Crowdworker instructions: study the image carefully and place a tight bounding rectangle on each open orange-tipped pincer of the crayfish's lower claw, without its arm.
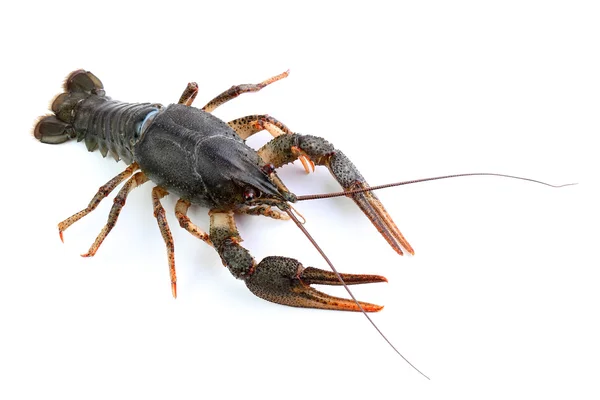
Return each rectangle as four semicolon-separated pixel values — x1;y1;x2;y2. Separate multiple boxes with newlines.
246;257;387;312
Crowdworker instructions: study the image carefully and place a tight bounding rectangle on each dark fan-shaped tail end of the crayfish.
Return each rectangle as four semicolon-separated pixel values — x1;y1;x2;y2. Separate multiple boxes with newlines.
33;69;104;144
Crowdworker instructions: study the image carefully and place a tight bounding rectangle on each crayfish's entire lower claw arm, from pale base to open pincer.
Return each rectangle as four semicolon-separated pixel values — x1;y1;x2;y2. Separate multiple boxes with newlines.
210;210;387;312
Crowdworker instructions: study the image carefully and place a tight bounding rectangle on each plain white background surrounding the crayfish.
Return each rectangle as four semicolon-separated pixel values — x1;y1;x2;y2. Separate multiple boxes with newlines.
0;0;600;399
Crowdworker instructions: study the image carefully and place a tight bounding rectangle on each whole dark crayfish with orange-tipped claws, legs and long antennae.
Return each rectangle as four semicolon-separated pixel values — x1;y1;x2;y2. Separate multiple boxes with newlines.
34;70;572;378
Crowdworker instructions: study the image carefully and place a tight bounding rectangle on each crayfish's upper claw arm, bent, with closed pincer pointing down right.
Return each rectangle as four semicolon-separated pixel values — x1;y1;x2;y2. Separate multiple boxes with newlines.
258;134;414;255
